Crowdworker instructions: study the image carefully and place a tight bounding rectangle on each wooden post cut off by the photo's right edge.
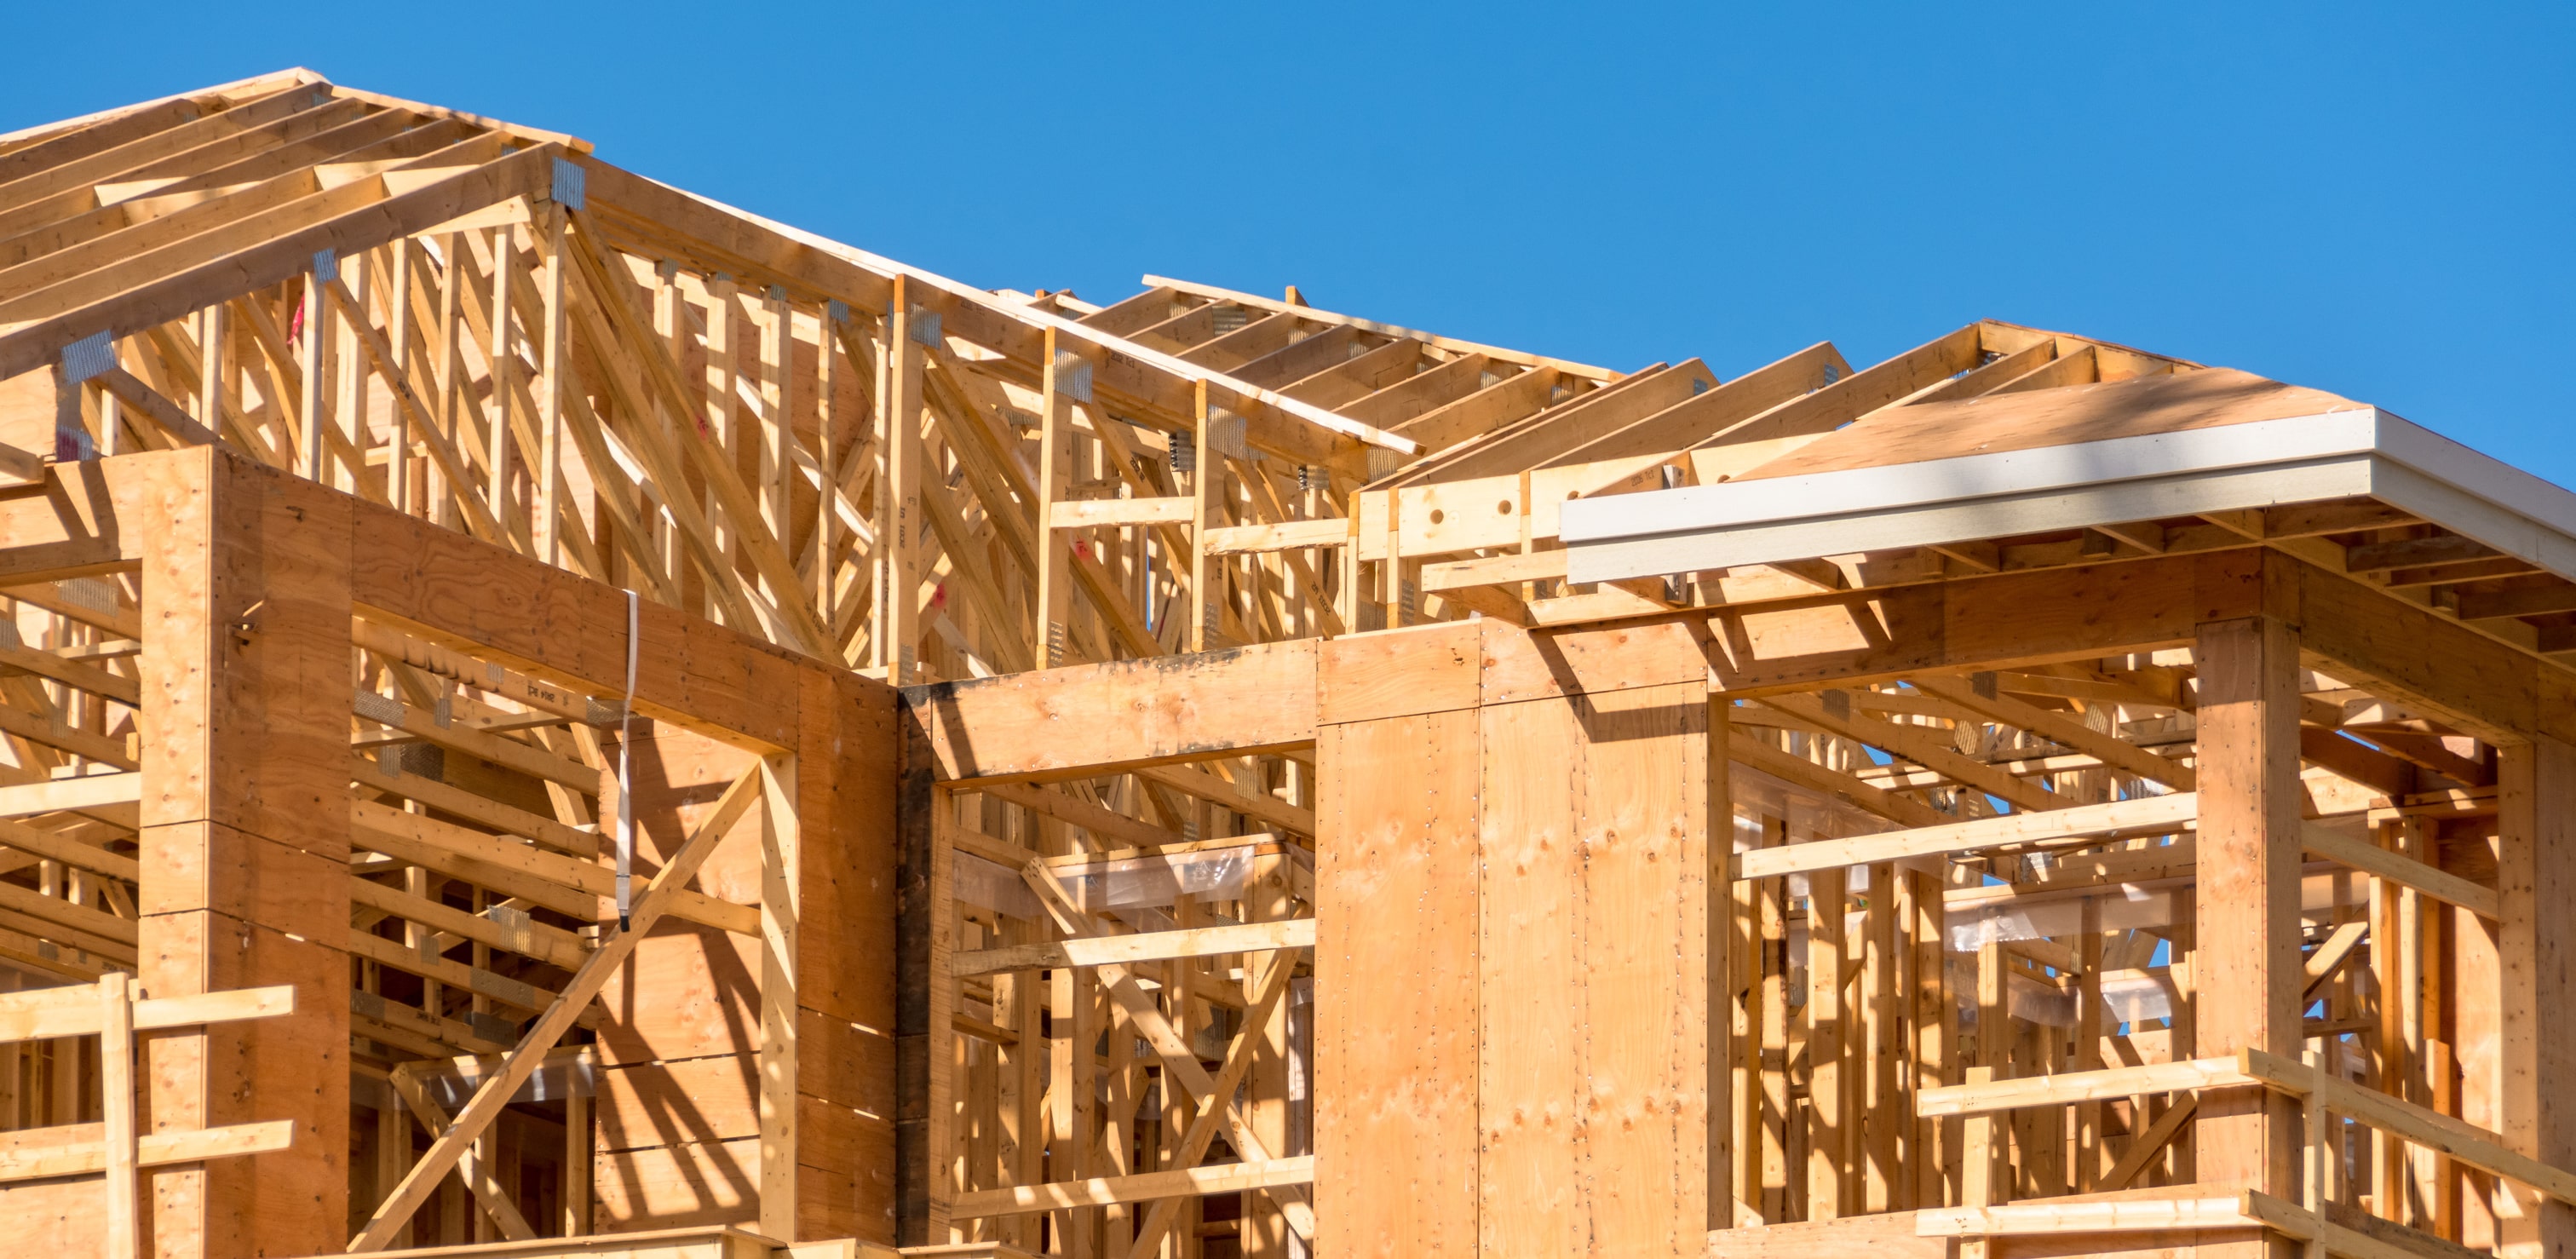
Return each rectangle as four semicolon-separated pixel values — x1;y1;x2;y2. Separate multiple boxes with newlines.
2496;736;2576;1259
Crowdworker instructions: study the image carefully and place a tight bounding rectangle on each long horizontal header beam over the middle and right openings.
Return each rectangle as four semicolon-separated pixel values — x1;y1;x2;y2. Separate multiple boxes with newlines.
904;551;2576;783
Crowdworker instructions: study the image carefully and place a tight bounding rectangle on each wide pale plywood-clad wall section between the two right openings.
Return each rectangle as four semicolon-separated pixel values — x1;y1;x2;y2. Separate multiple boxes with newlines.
1316;623;1723;1254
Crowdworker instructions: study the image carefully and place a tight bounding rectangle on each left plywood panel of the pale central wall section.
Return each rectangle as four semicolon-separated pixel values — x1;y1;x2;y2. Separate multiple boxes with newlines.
1314;710;1481;1256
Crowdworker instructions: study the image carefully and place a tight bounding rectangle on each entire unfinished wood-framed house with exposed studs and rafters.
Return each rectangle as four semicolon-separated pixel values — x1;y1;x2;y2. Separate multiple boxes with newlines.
0;72;2576;1259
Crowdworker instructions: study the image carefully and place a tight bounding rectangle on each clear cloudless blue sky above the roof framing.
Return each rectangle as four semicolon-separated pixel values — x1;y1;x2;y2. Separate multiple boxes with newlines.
0;3;2576;484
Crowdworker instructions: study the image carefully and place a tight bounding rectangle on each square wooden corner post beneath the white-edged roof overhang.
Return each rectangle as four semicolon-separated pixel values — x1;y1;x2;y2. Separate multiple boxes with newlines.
2176;618;2303;1256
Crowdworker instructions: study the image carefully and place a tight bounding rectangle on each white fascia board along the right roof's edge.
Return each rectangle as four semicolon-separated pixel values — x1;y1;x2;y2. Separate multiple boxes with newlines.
1561;407;2576;592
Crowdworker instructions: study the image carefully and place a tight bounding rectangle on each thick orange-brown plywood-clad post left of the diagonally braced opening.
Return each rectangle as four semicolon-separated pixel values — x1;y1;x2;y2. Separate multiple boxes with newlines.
137;448;353;1259
